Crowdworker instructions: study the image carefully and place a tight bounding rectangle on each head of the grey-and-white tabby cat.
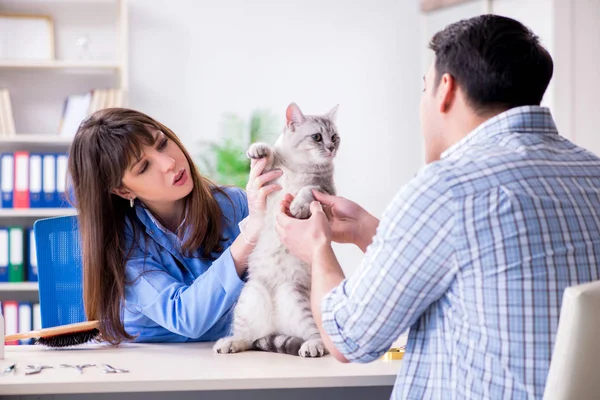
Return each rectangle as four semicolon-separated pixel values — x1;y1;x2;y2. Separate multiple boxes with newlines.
282;103;340;164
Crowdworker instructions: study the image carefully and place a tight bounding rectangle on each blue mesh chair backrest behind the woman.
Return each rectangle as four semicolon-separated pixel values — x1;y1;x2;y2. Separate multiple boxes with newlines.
33;216;86;328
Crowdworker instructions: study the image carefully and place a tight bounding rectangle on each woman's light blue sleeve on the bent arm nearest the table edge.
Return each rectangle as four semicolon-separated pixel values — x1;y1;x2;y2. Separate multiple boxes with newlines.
126;249;244;338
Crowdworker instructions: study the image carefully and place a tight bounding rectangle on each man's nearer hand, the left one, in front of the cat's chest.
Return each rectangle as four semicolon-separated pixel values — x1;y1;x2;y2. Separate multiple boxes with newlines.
275;193;331;264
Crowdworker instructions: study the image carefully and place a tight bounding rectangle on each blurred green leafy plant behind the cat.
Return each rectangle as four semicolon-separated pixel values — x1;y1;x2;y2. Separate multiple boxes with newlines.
197;110;276;188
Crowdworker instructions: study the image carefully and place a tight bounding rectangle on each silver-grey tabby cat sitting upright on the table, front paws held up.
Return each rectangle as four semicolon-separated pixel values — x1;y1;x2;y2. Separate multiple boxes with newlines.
213;103;340;357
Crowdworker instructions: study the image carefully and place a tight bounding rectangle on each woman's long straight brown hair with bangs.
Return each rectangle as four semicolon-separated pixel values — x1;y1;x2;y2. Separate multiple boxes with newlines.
69;108;230;344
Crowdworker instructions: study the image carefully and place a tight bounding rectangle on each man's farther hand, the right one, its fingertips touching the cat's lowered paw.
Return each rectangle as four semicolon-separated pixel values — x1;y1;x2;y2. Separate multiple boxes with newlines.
313;190;379;252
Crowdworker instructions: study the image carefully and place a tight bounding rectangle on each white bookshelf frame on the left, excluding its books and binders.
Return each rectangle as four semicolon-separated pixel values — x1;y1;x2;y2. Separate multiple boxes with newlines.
0;0;128;302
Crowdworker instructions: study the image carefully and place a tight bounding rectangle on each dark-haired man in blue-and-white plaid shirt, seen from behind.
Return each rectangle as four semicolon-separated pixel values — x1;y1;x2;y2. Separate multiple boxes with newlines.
277;15;600;399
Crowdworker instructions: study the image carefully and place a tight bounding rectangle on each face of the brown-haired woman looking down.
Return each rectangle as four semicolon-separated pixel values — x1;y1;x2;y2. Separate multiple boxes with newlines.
119;128;194;206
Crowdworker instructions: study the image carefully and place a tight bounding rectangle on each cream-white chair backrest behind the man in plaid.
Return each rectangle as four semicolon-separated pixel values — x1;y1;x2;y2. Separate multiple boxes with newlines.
544;281;600;400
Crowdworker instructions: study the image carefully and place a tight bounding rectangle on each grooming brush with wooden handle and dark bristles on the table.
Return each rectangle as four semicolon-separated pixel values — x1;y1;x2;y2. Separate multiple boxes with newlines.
4;321;100;347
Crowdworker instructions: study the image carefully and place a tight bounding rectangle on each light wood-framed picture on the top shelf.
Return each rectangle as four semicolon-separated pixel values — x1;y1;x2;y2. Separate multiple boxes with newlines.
0;14;54;60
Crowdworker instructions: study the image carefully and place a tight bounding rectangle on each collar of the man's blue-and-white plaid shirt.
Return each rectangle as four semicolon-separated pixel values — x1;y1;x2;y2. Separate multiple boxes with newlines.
441;106;558;158
